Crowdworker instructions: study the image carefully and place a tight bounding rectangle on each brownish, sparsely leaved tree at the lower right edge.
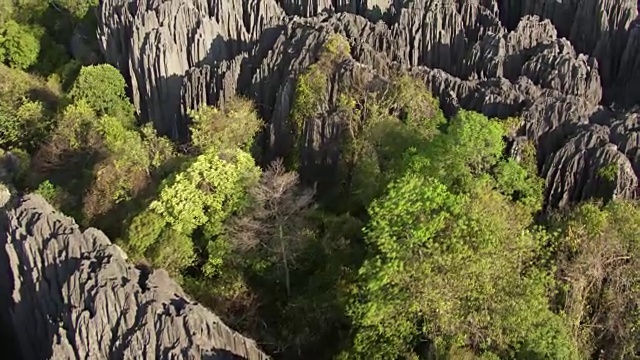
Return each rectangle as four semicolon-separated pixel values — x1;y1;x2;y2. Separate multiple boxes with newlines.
557;204;640;359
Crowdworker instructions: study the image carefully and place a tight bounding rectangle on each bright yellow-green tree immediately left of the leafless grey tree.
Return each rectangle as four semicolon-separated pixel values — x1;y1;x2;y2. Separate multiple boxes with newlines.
124;149;260;275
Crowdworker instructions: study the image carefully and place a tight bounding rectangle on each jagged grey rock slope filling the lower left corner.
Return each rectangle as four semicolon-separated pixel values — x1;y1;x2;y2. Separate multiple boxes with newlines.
0;195;268;360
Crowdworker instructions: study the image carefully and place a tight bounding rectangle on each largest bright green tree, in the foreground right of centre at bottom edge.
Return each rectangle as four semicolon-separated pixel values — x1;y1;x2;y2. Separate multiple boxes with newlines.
342;174;573;359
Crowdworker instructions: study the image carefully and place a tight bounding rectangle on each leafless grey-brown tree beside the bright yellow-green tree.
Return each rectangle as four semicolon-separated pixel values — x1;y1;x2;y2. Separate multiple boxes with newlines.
230;159;315;296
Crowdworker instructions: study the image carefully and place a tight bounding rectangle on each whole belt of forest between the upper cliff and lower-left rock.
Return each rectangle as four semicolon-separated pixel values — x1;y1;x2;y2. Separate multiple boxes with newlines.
0;10;640;360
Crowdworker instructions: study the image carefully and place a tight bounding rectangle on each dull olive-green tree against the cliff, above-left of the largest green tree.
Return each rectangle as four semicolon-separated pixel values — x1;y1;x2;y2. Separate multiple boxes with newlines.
338;75;445;211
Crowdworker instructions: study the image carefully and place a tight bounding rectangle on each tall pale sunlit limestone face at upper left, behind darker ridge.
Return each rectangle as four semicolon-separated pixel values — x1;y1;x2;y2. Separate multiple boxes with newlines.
98;0;284;139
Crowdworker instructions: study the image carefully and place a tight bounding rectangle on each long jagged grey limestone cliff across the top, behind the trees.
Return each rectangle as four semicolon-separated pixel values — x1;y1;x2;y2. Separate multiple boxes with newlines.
99;0;640;206
